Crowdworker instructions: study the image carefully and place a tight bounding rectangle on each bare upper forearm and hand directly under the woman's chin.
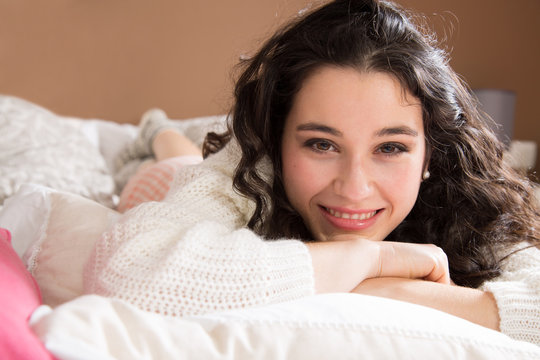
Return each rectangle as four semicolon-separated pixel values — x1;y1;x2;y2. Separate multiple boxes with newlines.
307;234;450;293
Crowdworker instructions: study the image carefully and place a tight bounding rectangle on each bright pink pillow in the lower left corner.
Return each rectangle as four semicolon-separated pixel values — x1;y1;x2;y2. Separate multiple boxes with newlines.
0;228;53;359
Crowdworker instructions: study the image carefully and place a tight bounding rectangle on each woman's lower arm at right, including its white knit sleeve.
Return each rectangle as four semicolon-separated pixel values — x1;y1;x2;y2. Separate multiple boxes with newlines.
353;244;540;345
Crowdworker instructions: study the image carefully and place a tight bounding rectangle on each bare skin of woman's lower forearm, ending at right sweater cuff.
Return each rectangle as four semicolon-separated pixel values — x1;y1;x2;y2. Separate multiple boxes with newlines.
353;277;499;330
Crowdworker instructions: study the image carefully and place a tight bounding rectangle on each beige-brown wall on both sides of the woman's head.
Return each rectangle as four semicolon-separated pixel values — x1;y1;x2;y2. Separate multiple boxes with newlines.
0;0;540;177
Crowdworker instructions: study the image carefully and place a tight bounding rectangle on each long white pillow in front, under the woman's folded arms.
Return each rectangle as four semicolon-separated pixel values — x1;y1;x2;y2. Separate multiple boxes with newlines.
30;294;540;360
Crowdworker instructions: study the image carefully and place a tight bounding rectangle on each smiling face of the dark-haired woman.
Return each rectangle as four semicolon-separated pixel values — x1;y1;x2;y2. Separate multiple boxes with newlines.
282;66;426;241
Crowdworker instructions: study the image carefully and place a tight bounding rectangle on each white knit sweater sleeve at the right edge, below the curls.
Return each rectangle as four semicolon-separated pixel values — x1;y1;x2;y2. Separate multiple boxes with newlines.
481;247;540;345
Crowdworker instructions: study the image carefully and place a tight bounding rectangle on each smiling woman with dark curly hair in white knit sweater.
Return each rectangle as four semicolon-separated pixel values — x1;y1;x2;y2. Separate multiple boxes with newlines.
86;0;540;344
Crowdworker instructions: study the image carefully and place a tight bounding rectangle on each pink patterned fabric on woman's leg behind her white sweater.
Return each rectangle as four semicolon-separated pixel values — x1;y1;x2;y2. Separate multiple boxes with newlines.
117;156;202;212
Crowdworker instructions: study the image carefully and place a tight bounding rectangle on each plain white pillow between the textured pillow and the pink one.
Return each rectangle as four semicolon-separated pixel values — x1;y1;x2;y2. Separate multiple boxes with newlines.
0;184;119;306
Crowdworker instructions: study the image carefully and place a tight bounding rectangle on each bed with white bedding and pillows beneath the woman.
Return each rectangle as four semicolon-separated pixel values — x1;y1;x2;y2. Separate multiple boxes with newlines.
0;95;540;360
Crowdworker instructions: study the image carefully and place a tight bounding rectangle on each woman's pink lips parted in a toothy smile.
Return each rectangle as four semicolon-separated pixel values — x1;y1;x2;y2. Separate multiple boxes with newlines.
319;206;382;231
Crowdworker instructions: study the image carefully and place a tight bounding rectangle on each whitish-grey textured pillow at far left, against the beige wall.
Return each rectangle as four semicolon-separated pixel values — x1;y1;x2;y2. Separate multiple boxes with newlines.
0;96;114;206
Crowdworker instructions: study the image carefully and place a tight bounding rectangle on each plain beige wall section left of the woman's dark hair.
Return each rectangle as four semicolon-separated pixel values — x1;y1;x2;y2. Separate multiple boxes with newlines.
0;0;306;122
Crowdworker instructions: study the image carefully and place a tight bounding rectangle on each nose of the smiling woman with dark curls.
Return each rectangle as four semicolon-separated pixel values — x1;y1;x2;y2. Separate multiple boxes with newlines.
334;161;373;200
